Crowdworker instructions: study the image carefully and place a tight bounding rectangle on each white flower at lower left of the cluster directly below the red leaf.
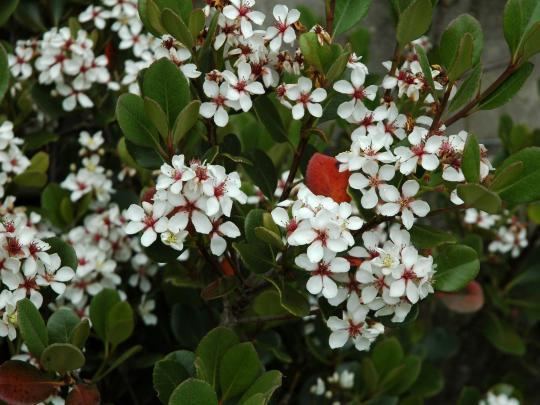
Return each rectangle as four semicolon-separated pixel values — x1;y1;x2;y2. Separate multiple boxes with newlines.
294;249;350;299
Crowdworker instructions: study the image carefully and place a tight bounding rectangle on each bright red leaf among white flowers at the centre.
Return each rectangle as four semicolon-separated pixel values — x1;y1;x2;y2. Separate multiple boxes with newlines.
306;153;351;203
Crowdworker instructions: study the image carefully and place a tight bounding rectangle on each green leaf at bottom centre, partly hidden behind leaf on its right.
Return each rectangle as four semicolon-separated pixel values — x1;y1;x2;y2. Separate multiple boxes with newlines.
195;327;239;388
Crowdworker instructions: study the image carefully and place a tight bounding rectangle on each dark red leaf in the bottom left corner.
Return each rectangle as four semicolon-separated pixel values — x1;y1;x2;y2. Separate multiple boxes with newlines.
0;360;60;405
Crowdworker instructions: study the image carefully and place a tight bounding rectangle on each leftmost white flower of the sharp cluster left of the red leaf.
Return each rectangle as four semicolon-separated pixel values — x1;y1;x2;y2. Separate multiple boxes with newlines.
125;201;168;247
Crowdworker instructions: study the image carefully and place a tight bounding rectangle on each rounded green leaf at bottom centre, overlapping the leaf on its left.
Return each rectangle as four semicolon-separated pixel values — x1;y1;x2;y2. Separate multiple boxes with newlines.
219;342;262;400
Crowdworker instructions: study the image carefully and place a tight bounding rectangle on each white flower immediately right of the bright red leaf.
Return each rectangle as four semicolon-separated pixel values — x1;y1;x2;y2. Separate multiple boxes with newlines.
349;161;396;209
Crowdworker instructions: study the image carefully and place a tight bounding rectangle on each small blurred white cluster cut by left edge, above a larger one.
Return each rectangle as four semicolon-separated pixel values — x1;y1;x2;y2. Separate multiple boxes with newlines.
0;121;30;198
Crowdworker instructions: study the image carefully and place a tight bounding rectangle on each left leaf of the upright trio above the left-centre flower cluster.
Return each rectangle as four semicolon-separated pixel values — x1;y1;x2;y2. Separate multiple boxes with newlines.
116;93;159;149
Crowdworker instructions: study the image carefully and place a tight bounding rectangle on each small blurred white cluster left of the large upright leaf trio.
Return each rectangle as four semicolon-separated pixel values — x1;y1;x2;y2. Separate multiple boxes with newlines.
61;131;114;203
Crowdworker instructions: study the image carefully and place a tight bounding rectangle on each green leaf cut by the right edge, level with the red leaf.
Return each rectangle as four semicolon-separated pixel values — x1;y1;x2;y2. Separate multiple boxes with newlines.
497;146;540;204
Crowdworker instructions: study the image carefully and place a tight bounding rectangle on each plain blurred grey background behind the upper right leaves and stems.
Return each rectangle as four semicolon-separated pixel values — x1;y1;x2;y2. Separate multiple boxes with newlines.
257;0;540;143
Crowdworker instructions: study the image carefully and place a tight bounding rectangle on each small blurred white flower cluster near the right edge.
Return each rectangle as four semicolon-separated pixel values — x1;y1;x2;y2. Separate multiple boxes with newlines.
464;208;529;257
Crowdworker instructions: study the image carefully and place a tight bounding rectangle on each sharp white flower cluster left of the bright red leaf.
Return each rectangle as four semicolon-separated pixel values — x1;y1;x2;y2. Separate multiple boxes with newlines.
125;155;247;256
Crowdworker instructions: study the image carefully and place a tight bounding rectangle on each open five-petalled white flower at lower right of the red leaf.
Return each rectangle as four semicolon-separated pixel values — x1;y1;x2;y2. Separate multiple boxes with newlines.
380;180;429;229
